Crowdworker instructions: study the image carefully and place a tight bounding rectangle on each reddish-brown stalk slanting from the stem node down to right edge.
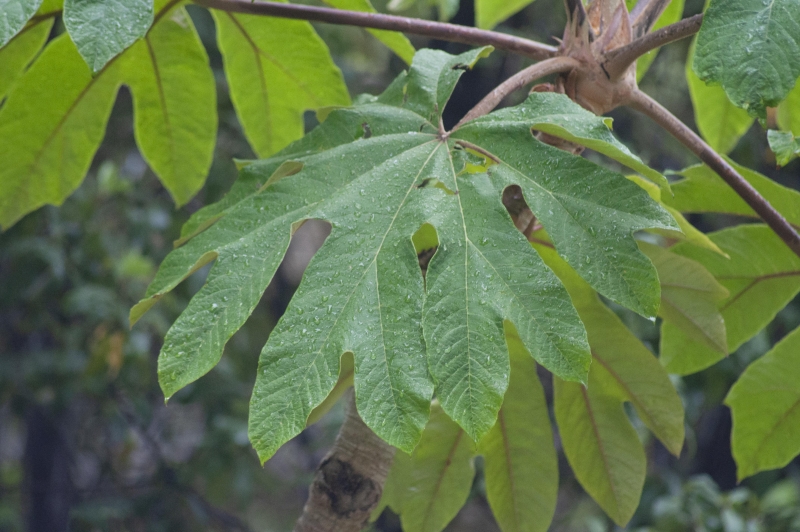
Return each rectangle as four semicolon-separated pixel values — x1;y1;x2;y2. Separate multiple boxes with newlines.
627;89;800;257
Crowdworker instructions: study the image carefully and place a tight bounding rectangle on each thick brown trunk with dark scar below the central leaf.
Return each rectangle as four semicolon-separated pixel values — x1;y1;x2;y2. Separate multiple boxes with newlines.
294;389;395;532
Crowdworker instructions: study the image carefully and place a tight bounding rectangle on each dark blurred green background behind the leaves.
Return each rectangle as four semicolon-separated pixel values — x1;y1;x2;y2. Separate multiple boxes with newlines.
0;0;800;532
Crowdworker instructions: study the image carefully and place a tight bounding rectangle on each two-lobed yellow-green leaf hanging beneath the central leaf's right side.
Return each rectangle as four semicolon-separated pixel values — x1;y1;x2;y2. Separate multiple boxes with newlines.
536;244;684;525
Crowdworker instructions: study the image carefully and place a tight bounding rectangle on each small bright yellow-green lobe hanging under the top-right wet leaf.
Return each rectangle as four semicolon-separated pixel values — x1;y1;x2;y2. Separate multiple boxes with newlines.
686;38;755;153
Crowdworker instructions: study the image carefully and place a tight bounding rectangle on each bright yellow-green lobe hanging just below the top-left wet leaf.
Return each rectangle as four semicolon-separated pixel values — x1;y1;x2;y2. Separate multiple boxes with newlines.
121;5;217;205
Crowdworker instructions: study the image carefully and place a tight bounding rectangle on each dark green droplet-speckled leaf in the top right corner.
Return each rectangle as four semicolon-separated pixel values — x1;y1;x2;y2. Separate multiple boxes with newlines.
694;0;800;117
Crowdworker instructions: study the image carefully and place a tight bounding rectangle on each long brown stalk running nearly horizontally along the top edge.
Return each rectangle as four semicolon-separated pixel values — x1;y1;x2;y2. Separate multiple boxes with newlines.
194;0;557;59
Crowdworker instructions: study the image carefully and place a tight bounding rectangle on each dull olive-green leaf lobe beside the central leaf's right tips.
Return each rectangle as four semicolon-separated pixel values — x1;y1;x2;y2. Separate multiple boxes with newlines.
639;242;728;355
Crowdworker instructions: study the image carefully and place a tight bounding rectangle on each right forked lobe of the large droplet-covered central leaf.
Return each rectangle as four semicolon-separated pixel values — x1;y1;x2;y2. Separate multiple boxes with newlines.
453;109;678;317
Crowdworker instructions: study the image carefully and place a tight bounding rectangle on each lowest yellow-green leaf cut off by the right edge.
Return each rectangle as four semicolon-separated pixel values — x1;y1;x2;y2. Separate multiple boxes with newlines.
725;329;800;480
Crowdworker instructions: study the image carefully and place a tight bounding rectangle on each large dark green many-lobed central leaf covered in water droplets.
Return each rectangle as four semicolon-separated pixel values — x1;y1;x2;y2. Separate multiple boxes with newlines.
131;49;677;459
